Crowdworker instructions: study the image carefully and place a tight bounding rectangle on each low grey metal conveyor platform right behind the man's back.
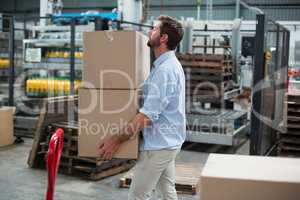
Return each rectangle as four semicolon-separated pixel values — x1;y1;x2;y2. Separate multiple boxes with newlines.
186;109;249;146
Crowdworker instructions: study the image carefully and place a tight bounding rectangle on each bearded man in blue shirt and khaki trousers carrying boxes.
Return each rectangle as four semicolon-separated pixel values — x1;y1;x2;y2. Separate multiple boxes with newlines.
100;16;186;200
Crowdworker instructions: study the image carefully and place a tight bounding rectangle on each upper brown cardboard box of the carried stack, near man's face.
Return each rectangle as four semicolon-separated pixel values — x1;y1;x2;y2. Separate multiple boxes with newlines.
82;31;150;89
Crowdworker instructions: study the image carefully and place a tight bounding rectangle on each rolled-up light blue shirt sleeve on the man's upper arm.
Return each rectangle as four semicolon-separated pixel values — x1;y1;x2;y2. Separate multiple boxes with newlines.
139;70;175;122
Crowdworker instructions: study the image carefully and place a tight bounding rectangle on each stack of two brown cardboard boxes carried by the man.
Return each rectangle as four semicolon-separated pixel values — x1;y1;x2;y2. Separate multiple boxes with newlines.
78;31;150;159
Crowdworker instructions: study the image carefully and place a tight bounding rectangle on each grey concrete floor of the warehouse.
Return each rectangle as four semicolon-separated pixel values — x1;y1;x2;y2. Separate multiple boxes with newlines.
0;139;248;200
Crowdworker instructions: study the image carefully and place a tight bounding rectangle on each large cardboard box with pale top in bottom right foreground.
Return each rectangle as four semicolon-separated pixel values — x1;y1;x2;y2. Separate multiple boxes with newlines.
200;154;300;200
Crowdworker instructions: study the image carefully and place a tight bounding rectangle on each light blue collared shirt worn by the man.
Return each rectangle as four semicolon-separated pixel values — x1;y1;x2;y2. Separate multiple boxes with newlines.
139;51;186;150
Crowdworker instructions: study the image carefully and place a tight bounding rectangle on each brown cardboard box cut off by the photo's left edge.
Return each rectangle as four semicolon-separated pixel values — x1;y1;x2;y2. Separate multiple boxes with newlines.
0;107;15;147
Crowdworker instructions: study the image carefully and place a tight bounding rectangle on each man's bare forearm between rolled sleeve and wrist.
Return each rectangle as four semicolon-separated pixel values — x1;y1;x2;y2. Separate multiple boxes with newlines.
118;113;151;143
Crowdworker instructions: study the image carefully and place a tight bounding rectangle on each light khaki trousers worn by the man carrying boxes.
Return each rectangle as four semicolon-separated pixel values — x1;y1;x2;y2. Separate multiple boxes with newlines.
128;149;180;200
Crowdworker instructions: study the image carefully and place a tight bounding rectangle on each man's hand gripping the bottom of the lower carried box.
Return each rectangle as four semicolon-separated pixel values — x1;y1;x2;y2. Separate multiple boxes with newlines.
99;135;122;160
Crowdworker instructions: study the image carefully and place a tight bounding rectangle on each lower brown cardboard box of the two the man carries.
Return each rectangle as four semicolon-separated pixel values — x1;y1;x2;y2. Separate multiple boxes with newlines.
78;89;138;159
